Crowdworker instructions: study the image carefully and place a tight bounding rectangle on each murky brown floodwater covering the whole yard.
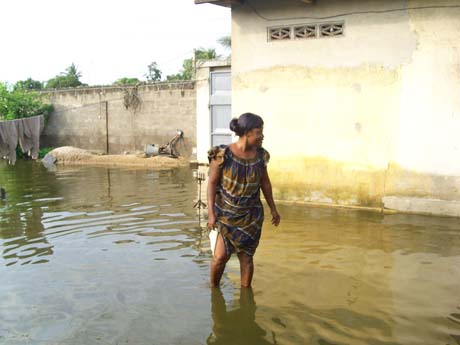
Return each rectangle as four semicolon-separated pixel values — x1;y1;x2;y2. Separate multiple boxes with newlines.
0;161;460;345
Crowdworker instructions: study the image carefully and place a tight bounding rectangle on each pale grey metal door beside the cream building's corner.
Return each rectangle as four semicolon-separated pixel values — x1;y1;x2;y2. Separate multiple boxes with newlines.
209;71;232;146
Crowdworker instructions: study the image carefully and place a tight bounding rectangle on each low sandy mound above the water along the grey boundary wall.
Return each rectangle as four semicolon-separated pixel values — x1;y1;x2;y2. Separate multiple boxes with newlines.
48;146;189;168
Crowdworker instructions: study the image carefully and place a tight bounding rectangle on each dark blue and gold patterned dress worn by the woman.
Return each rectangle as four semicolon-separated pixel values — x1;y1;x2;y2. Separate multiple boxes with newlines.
208;145;270;256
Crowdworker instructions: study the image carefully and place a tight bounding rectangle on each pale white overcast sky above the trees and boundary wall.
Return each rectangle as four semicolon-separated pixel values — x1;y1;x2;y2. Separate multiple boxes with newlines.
0;0;231;85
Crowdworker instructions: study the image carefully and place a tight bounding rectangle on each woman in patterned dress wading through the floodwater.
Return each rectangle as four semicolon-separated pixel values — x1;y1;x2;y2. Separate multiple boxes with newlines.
208;113;280;287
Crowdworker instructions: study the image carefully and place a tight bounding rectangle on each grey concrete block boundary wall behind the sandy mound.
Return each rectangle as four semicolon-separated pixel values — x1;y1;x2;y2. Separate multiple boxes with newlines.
41;82;196;158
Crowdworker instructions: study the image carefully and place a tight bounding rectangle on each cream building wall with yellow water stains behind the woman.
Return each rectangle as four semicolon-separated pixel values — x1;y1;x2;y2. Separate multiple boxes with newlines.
195;0;460;216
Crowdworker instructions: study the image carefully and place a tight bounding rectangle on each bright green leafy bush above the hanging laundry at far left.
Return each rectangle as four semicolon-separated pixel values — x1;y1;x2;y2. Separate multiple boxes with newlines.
0;83;53;120
